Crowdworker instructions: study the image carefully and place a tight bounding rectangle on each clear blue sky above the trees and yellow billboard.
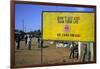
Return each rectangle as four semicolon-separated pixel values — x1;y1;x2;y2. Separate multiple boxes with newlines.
15;4;94;32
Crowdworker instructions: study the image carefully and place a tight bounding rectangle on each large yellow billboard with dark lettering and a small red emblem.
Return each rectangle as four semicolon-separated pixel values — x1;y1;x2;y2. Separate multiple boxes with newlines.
43;12;94;41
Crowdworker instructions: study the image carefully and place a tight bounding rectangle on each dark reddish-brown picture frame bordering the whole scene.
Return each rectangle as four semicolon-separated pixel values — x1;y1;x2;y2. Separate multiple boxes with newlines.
10;0;96;69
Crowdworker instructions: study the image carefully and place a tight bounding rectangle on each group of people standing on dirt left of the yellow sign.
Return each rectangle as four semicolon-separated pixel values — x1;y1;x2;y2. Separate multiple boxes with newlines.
16;35;41;50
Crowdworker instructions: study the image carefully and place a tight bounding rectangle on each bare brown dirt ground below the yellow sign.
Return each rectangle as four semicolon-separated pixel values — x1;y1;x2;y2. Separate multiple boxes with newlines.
15;38;79;66
